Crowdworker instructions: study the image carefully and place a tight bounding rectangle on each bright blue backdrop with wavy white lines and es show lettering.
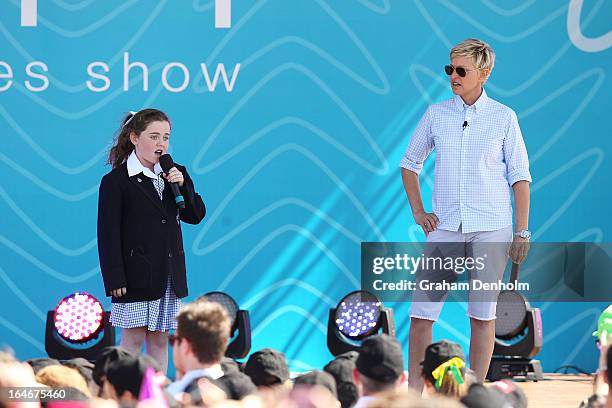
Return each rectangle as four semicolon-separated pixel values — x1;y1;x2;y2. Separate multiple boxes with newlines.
0;0;612;371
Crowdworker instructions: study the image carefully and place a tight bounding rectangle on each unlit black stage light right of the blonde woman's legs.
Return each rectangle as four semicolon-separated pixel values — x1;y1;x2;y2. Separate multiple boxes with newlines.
487;263;543;381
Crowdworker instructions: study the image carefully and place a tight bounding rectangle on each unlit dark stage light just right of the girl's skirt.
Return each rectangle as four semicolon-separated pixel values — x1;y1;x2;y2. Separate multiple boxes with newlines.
200;291;251;359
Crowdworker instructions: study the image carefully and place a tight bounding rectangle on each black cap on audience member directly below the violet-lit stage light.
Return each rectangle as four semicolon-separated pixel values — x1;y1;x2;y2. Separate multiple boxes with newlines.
355;334;404;383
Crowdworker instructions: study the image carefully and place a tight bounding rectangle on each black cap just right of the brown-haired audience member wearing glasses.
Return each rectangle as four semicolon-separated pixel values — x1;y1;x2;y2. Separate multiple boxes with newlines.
244;348;289;386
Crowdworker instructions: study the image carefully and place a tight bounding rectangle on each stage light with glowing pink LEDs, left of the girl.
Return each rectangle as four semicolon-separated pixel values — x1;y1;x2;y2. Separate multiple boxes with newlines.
45;292;115;361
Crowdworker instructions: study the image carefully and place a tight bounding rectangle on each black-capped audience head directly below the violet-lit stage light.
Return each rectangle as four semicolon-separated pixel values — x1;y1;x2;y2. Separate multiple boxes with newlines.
353;334;406;395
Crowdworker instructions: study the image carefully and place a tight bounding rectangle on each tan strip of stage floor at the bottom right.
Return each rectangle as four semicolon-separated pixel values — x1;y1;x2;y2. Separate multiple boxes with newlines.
515;374;593;408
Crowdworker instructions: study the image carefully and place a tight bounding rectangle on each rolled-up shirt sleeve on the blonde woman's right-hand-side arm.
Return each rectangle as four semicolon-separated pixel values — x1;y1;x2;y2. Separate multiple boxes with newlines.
504;111;531;186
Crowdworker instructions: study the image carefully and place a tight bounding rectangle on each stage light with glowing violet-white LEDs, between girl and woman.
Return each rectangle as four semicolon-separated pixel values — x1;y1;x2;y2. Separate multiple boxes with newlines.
327;290;395;356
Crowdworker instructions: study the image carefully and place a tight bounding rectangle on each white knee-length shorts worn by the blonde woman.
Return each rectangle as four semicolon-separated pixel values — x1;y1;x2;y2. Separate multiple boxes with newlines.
410;225;514;321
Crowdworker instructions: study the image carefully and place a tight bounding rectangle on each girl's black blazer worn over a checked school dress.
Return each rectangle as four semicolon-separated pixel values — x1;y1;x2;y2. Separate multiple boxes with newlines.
98;163;206;303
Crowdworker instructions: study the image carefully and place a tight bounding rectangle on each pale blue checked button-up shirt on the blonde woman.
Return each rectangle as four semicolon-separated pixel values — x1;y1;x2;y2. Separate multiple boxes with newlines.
400;89;531;233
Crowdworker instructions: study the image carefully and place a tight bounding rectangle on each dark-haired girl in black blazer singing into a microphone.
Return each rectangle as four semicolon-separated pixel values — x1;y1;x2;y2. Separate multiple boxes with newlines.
98;109;206;372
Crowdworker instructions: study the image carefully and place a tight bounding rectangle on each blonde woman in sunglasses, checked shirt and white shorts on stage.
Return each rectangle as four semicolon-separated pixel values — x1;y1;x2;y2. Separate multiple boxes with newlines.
400;38;531;390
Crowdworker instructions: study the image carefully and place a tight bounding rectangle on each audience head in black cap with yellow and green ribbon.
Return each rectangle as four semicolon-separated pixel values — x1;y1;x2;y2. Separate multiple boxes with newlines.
421;340;467;398
